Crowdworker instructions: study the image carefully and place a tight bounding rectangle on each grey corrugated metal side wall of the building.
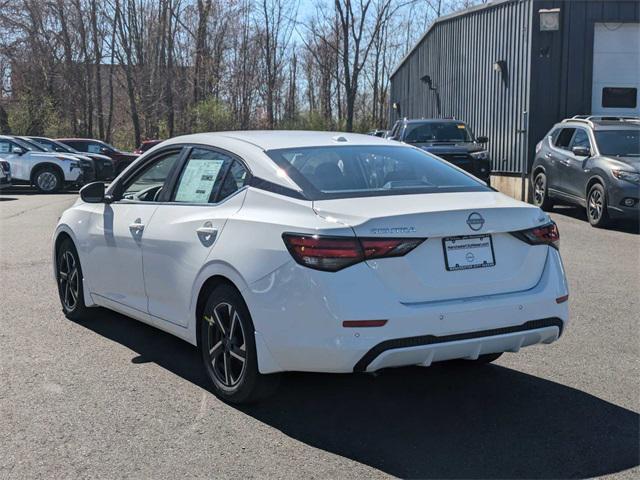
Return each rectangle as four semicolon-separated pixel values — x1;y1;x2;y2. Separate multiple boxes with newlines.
390;0;531;174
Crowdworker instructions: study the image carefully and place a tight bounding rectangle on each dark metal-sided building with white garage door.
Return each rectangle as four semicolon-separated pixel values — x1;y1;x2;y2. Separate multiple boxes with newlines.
390;0;640;198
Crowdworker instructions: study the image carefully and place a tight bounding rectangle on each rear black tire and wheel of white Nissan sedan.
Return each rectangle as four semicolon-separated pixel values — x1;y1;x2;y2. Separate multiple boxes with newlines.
200;285;280;404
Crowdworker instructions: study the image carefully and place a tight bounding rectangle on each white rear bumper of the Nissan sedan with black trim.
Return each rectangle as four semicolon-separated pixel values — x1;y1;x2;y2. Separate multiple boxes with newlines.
243;248;568;373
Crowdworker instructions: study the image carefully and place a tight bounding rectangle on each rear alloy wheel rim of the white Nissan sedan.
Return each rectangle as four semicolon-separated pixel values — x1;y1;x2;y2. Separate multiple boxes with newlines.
204;302;247;390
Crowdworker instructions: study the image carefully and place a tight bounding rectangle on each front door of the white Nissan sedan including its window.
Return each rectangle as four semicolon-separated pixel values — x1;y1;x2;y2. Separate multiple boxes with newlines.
85;149;181;314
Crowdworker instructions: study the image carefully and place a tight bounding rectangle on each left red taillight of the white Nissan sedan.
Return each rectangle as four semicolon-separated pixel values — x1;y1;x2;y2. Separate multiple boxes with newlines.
282;233;425;272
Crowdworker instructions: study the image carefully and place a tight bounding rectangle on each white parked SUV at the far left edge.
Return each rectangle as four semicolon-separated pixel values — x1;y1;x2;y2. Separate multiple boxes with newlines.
0;135;93;193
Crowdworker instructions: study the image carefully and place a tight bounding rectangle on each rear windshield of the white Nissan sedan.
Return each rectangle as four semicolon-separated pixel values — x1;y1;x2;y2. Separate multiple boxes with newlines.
266;145;491;200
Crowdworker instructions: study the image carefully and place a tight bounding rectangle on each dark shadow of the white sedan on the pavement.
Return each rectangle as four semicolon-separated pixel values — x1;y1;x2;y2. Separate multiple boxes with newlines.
81;309;640;478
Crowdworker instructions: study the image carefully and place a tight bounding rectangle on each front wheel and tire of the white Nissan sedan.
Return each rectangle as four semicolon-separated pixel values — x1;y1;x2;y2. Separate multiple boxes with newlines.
56;238;88;320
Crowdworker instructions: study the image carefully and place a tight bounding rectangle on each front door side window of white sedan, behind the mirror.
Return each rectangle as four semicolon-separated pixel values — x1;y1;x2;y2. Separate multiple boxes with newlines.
122;150;181;202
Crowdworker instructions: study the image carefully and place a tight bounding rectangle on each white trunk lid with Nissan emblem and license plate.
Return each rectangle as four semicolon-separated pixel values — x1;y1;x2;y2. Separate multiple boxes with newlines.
314;192;549;303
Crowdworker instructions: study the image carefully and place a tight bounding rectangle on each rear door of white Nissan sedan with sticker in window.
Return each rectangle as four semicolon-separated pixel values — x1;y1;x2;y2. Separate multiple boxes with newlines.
142;148;249;326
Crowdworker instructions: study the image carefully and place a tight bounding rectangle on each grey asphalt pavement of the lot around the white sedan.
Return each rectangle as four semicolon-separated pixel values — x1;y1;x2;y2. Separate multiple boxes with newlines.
0;189;640;479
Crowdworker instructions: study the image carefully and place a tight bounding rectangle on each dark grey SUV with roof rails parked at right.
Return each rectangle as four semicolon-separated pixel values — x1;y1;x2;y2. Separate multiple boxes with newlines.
531;116;640;227
